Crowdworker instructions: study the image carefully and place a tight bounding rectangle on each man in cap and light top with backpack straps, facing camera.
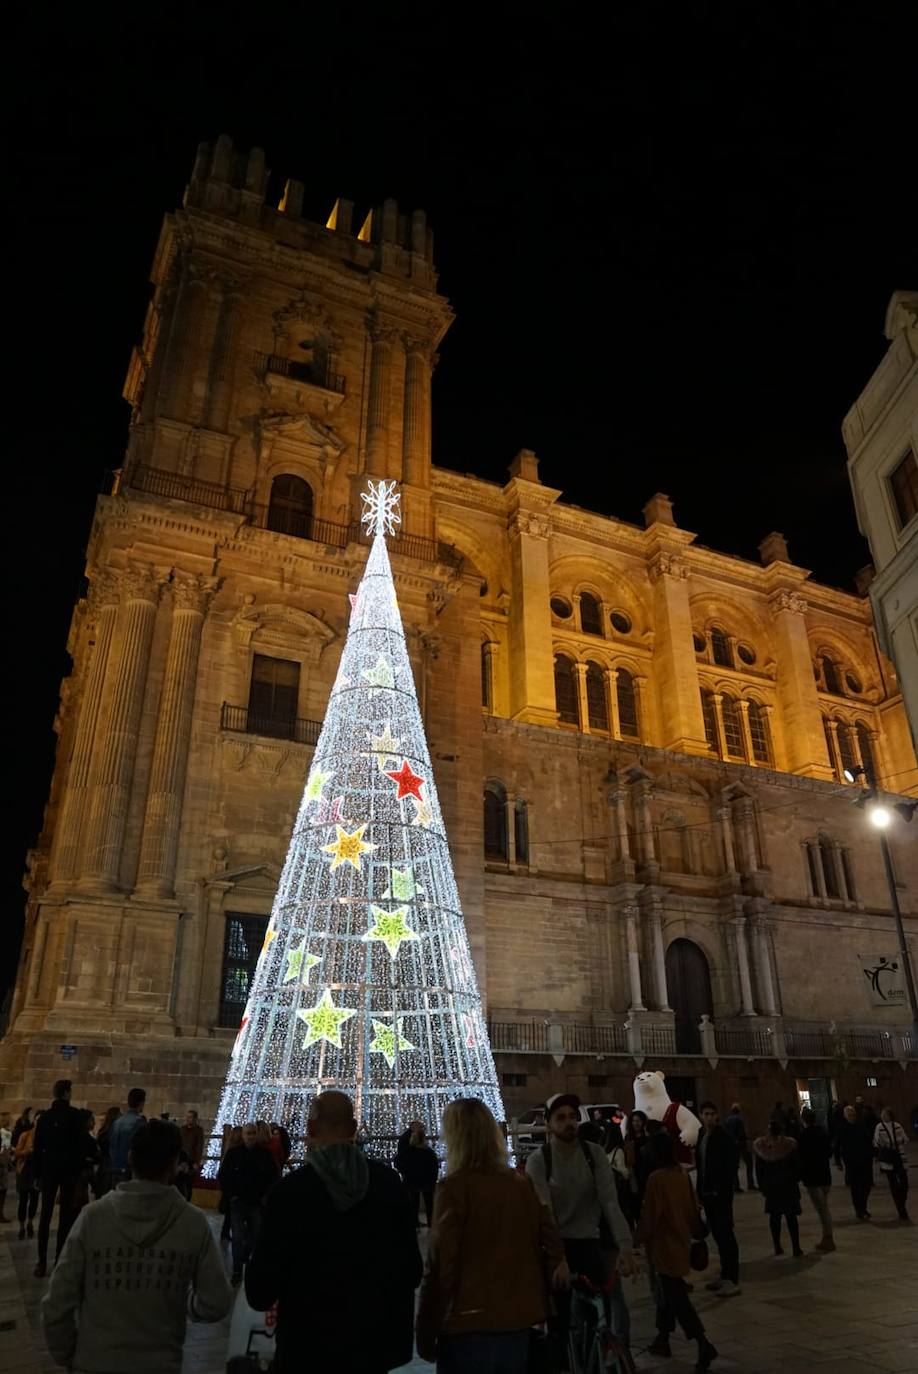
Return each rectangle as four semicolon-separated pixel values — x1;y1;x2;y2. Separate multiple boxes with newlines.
526;1092;635;1351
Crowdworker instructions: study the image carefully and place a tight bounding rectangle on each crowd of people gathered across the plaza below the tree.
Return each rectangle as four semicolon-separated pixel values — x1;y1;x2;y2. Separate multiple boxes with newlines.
0;1080;908;1374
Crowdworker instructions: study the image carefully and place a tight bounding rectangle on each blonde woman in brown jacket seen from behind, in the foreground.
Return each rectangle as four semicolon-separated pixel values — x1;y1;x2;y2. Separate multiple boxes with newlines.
418;1098;569;1374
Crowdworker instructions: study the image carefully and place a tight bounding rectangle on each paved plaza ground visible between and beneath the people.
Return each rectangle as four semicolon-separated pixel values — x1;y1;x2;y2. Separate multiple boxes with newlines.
0;1158;918;1374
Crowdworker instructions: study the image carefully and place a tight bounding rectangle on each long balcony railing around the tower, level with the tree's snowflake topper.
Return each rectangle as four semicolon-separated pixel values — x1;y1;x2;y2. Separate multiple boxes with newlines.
122;467;462;567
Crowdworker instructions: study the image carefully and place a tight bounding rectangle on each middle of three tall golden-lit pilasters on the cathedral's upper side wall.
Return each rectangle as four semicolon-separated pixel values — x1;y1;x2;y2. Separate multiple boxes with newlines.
650;551;709;754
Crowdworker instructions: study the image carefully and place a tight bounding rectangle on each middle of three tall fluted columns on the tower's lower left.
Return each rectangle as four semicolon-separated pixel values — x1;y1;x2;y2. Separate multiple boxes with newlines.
80;570;159;892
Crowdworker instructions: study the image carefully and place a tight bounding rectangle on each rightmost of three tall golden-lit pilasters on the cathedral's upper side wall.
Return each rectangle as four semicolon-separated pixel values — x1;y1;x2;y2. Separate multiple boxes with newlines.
770;588;831;780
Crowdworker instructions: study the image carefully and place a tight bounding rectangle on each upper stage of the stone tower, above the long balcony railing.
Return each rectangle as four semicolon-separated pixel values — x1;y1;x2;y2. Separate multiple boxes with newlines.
125;135;452;539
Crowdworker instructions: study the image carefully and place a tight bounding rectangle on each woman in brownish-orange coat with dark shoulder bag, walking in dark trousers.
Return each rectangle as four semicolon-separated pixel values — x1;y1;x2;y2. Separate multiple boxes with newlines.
635;1131;717;1370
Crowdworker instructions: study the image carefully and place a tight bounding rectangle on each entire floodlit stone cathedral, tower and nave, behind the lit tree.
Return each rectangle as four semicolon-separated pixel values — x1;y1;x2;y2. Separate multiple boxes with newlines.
0;137;918;1124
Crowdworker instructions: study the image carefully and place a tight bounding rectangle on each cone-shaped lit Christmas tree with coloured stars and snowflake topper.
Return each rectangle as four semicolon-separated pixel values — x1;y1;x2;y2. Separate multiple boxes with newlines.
206;482;503;1153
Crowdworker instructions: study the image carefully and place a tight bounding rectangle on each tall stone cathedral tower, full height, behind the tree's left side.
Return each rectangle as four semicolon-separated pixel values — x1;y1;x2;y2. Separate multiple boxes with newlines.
0;136;456;1103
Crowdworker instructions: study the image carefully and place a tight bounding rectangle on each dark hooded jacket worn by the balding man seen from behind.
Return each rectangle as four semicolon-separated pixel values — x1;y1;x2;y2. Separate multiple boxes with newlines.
246;1145;422;1374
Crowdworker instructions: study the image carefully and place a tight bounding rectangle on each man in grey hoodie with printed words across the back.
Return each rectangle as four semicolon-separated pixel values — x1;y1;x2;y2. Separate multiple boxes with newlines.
41;1121;234;1374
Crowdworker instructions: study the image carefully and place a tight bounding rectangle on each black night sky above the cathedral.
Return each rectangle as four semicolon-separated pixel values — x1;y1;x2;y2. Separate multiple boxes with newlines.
0;3;918;996
